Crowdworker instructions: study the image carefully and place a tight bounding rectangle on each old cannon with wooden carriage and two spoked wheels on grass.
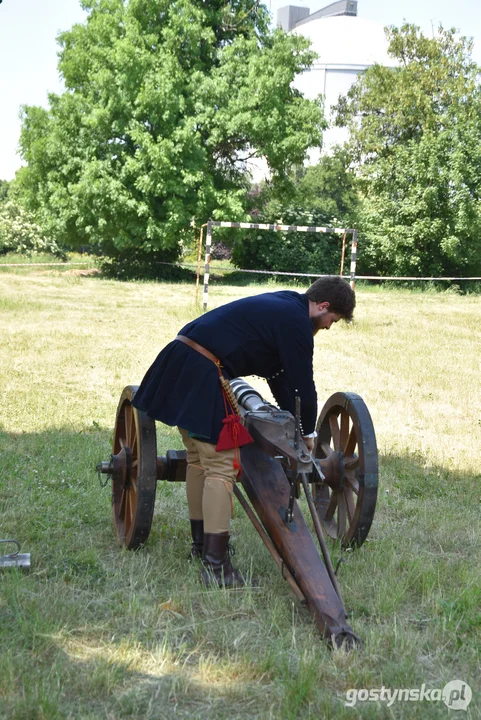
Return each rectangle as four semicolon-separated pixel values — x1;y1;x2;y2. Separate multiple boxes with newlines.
97;378;378;647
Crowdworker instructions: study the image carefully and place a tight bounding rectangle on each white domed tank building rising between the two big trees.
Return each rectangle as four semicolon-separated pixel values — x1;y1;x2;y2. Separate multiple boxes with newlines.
277;0;395;153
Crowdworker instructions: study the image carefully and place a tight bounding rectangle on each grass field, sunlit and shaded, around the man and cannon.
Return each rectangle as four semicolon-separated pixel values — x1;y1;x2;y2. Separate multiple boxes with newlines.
0;268;481;720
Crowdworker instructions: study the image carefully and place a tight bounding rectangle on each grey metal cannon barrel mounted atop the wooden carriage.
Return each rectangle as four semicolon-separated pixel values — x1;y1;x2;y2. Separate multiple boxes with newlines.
230;378;313;477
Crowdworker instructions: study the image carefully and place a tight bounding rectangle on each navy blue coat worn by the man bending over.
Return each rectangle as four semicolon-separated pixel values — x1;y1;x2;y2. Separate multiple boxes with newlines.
134;291;317;444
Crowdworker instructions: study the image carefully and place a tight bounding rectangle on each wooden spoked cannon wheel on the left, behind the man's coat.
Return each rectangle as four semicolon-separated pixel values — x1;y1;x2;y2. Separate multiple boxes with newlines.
109;385;157;550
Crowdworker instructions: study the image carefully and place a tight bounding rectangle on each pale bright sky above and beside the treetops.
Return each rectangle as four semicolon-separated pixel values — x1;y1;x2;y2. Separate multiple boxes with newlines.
0;0;481;180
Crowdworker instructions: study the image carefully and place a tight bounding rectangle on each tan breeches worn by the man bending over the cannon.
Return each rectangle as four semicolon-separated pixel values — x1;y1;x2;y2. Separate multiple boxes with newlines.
179;428;237;533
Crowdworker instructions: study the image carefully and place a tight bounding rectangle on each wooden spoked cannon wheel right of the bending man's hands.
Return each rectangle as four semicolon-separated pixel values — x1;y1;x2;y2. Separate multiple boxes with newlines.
312;392;378;547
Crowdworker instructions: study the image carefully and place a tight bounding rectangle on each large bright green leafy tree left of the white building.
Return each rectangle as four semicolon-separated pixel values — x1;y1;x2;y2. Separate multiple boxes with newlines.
19;0;323;256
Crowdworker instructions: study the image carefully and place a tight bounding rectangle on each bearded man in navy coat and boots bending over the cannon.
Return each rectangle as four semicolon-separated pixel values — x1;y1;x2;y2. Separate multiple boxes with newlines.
134;276;356;587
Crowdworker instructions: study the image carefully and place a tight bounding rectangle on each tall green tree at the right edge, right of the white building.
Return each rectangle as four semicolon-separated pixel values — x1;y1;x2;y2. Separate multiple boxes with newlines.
337;25;481;276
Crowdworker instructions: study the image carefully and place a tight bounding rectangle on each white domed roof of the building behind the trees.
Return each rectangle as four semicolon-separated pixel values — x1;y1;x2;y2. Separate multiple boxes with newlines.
291;15;396;67
